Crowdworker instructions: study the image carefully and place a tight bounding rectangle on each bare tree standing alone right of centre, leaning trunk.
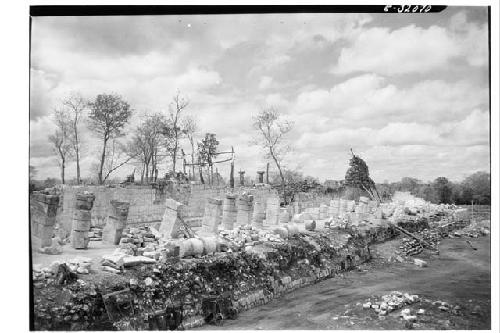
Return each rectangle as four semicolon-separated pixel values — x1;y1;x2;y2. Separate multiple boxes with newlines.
253;107;293;202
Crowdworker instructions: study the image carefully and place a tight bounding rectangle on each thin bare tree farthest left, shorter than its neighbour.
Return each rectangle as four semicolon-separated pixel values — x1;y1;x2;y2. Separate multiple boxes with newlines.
49;109;72;184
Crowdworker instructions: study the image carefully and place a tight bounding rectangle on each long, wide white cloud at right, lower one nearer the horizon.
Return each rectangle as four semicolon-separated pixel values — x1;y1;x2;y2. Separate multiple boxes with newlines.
293;74;488;130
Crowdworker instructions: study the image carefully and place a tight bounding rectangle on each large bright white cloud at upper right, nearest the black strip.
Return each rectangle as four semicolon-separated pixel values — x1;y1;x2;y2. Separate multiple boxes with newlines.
332;13;488;76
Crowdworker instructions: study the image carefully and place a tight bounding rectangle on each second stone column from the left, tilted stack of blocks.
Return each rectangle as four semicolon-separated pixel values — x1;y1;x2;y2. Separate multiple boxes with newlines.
71;192;95;249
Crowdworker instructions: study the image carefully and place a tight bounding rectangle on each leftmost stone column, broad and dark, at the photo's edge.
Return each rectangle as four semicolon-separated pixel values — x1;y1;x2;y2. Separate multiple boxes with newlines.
30;191;59;247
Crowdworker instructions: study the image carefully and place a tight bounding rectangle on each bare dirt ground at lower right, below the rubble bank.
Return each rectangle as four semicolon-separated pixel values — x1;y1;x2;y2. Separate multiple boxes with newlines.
199;236;491;330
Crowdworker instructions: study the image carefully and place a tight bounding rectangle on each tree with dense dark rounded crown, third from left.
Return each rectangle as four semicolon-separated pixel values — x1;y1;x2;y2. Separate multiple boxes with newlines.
89;94;132;184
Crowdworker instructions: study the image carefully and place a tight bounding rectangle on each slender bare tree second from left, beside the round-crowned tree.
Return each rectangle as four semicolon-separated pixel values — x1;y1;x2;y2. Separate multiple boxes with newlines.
62;93;88;184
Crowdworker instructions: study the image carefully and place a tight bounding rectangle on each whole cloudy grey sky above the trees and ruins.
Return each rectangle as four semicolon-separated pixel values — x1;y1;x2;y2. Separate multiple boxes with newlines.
30;7;489;182
